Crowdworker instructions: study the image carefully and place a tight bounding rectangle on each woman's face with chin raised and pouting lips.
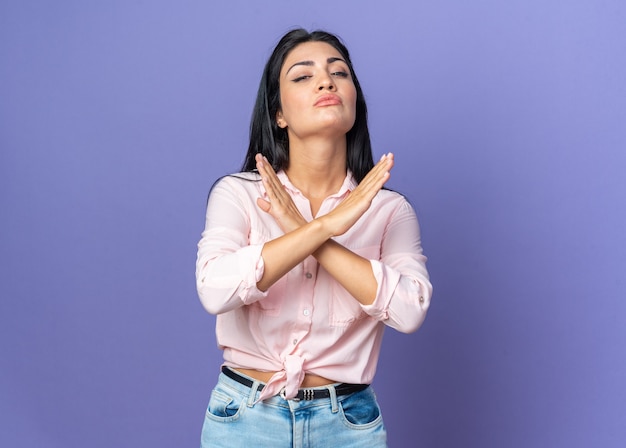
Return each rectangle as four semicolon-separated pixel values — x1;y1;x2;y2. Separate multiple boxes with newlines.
276;42;357;141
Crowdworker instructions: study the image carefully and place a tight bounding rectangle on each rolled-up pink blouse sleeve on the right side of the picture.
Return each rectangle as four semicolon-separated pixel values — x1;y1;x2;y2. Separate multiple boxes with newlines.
363;201;432;333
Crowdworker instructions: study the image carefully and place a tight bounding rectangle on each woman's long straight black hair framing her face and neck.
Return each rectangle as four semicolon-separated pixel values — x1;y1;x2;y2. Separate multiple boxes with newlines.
241;28;374;182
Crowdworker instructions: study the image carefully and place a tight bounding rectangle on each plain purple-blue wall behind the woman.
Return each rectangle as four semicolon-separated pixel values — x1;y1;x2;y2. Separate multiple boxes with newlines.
0;0;626;448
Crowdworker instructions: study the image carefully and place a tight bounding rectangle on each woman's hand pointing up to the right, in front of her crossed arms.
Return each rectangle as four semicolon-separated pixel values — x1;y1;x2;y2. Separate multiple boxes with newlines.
318;153;394;236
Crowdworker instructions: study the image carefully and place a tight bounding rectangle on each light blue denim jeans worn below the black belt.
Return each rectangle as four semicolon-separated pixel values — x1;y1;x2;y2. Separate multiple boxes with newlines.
201;373;387;448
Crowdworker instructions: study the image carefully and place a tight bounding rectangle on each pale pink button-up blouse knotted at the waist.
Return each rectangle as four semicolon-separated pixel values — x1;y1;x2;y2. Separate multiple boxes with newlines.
196;171;432;400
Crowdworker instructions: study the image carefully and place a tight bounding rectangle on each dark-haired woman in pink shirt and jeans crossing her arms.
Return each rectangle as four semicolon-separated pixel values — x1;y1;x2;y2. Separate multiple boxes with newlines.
196;29;432;448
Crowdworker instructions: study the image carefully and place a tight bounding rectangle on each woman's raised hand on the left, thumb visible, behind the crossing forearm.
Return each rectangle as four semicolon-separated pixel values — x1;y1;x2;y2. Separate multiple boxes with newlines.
255;154;307;233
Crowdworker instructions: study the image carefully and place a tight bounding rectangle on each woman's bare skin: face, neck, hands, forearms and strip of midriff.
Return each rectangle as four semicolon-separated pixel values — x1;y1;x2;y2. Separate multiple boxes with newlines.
234;42;394;387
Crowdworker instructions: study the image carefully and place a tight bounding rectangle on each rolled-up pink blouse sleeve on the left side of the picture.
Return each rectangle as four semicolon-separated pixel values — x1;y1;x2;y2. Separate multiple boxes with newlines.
196;178;266;314
